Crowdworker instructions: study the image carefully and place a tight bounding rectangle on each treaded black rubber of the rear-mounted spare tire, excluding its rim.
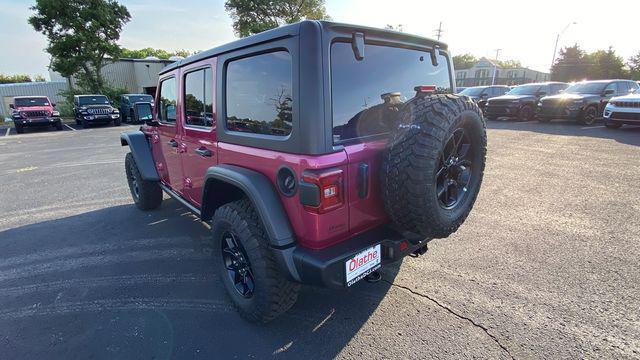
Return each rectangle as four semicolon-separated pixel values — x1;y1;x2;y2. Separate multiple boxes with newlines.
381;95;487;238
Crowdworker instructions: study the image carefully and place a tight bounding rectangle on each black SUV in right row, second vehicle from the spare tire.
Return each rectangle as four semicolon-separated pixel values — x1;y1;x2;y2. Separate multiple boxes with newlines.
485;82;569;121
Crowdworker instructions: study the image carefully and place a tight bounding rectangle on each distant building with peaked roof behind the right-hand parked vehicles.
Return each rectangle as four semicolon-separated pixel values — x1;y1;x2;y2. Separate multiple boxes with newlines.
455;57;549;87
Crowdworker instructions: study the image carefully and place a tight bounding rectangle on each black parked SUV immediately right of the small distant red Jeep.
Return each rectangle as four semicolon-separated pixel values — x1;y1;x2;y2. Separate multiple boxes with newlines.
73;95;121;128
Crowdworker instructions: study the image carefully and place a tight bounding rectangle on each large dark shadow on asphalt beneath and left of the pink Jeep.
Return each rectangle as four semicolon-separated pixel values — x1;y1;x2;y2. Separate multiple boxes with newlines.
0;200;399;359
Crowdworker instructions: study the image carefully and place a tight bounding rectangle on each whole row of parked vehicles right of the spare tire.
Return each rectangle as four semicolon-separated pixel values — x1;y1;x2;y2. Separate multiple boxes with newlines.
459;79;640;127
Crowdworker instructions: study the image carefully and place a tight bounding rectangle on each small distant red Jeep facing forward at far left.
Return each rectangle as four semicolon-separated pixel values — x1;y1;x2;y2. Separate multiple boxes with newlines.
9;96;62;134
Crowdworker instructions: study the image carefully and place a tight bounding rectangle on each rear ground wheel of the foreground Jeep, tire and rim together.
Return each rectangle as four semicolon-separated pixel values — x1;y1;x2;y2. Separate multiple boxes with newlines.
211;198;300;323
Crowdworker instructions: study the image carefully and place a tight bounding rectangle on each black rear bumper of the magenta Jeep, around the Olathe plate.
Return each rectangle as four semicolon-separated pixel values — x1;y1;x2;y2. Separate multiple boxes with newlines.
273;226;427;288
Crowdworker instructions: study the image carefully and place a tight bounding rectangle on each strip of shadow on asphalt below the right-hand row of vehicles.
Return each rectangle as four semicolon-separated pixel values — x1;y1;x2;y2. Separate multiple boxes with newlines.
487;120;640;146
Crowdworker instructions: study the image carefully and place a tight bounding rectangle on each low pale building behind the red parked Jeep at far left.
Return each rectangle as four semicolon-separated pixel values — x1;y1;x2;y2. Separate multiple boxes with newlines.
0;81;67;117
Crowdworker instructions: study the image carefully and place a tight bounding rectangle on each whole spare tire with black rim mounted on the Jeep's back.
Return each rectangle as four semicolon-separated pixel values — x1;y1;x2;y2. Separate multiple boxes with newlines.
381;95;487;238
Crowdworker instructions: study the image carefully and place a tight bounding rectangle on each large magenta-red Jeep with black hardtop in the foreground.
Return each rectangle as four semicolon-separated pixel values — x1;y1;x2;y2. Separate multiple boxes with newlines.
121;21;486;322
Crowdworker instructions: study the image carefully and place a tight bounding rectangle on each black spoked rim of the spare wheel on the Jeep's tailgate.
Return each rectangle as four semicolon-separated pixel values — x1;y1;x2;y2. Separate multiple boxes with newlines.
435;127;475;209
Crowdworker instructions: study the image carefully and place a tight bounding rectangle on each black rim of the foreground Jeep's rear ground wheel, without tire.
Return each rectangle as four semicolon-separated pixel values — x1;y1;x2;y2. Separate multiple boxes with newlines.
220;231;255;299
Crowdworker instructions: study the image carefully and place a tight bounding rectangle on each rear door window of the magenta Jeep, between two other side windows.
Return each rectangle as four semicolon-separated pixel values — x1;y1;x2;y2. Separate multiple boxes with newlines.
184;68;213;128
